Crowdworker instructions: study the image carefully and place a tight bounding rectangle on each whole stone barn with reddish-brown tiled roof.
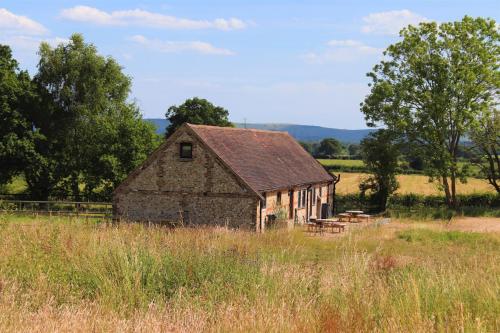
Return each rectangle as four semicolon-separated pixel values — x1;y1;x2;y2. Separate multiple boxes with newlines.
113;124;334;231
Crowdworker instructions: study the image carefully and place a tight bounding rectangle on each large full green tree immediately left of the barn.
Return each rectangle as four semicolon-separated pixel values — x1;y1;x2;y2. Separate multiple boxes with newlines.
29;34;156;200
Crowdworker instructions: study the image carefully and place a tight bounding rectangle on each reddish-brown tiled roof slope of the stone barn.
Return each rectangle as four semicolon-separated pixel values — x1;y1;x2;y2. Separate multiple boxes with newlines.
188;124;333;192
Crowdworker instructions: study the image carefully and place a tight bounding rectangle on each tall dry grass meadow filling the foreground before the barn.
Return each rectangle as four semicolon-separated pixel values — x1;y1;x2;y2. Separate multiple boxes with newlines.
0;215;500;332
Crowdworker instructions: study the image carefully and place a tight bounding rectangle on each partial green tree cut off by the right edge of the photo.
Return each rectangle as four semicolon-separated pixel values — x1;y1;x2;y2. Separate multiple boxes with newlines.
469;109;500;193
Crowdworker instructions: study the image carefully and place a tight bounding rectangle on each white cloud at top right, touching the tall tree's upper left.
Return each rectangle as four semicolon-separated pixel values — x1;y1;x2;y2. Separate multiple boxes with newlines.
361;9;429;35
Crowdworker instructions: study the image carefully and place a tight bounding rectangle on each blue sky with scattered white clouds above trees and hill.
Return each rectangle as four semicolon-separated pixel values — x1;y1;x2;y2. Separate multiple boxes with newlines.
0;0;500;129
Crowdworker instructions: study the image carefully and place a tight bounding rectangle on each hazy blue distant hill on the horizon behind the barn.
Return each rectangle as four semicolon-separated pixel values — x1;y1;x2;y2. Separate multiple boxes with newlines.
146;119;374;143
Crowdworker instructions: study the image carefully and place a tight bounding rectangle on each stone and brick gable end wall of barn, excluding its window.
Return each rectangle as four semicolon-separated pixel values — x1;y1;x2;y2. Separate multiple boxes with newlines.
113;130;258;229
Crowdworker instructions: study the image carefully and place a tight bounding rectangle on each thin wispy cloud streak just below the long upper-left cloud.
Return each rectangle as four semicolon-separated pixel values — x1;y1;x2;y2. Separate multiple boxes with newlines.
130;35;234;56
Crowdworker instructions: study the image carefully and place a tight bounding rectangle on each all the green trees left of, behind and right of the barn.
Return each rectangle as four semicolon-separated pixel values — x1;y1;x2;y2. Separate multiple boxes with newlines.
0;17;500;208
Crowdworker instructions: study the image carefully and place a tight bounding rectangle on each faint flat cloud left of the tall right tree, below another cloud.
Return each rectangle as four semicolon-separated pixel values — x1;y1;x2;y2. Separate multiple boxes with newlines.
302;39;382;64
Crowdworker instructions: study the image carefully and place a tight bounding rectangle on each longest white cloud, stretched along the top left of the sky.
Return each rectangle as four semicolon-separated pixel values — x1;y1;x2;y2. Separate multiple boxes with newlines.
61;6;247;30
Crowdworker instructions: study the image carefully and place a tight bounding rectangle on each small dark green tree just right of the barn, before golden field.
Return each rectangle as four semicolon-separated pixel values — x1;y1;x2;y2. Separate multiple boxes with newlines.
360;129;400;211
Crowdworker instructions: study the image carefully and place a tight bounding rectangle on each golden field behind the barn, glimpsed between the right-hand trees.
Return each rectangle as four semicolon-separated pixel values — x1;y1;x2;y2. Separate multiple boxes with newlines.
335;172;495;195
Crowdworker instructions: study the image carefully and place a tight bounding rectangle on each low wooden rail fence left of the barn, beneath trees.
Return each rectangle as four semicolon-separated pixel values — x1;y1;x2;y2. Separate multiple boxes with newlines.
0;199;113;220
